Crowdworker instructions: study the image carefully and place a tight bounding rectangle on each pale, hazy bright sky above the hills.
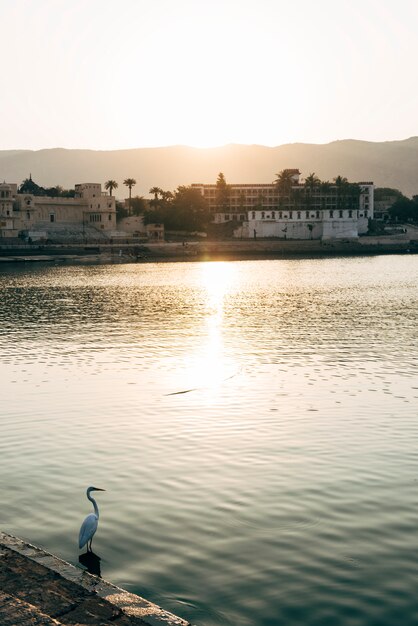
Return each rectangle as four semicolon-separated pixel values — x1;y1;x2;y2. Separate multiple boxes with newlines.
0;0;418;149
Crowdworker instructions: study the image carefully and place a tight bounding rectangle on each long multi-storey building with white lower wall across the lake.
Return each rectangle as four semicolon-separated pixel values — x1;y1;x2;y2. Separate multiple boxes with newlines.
192;169;374;239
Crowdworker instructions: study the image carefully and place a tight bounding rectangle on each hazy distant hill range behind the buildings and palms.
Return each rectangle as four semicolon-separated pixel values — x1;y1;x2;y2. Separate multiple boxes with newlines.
0;137;418;198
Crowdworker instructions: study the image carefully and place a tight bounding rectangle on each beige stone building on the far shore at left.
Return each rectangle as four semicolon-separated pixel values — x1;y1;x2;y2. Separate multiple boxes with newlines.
0;177;116;243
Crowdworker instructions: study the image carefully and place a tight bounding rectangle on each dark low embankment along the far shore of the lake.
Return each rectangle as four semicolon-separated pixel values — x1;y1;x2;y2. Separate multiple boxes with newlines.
0;231;418;263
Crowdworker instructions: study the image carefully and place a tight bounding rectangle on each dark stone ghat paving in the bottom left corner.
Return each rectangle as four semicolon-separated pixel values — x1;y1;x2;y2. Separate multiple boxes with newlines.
0;532;190;626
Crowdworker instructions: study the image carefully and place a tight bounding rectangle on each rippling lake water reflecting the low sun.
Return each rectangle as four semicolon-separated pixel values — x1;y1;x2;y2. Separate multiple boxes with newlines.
0;255;418;626
